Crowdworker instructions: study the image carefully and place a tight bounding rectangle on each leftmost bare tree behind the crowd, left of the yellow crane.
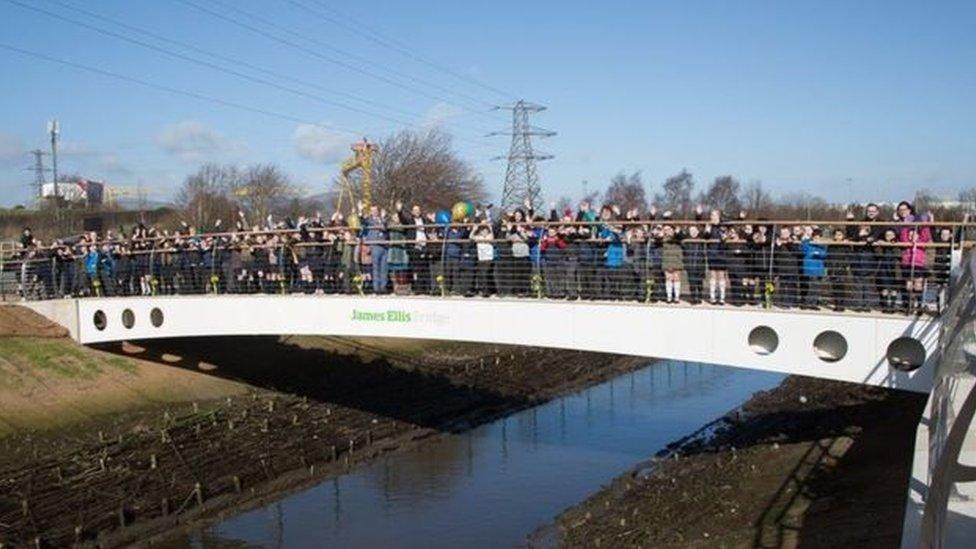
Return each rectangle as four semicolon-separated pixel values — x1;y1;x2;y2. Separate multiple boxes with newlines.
175;164;241;227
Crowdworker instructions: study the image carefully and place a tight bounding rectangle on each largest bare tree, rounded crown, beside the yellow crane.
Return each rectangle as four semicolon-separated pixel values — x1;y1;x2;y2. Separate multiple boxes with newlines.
342;128;486;208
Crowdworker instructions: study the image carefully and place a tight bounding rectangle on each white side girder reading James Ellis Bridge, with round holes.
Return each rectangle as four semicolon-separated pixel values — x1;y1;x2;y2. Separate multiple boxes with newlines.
25;295;939;392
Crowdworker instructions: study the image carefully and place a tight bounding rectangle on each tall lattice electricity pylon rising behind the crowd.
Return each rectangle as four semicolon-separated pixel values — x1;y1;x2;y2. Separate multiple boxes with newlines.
488;99;556;210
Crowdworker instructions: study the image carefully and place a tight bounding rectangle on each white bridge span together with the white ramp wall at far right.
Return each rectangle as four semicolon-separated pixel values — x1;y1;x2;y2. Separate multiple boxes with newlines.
24;284;976;547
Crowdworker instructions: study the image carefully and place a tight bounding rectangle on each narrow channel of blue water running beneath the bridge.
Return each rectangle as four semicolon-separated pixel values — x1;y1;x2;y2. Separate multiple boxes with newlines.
187;362;781;547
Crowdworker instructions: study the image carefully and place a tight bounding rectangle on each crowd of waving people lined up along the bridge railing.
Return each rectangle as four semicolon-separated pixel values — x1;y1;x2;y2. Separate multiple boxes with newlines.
3;201;961;312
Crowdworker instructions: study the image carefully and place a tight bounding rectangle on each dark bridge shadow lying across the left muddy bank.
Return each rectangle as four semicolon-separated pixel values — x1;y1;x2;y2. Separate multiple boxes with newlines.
96;336;531;430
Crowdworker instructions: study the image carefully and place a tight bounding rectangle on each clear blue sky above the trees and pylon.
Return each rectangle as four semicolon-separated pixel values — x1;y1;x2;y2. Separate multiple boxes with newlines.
0;0;976;205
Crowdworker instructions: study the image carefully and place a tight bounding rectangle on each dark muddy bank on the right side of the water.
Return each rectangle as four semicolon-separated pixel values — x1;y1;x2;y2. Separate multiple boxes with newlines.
532;377;925;548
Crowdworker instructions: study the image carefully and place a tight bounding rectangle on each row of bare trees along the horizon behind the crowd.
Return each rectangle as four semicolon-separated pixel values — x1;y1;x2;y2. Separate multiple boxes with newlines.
175;128;976;226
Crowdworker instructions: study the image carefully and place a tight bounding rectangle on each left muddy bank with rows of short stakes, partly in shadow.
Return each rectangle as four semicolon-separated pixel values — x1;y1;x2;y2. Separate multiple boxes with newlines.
0;328;648;547
